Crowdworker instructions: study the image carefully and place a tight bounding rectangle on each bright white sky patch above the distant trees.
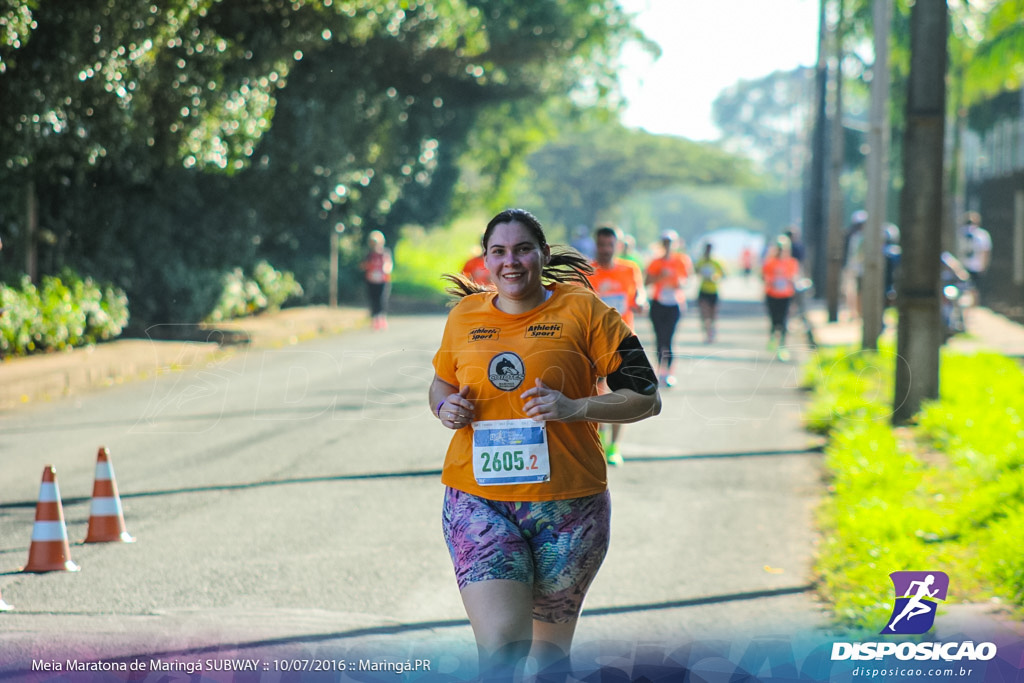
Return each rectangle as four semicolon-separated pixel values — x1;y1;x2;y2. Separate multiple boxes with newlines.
620;0;818;140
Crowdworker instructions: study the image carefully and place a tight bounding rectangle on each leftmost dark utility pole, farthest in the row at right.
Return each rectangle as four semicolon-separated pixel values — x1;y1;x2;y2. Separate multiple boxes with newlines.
804;0;828;297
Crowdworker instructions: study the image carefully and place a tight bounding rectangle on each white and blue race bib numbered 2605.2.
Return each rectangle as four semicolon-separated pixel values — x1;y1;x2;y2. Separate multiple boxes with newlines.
473;420;551;486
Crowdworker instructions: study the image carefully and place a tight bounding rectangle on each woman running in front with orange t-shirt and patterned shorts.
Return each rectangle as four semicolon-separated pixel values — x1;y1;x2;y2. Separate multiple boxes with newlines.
429;209;660;680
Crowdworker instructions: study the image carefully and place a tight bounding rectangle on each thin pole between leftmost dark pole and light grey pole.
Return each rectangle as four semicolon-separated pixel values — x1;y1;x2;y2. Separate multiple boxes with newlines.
825;0;846;323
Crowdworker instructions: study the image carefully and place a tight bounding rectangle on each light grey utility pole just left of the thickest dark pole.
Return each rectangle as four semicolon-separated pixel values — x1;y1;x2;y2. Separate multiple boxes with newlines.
860;0;892;350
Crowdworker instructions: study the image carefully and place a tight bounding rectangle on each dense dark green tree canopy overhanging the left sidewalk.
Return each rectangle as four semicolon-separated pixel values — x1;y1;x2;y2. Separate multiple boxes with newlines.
0;0;640;319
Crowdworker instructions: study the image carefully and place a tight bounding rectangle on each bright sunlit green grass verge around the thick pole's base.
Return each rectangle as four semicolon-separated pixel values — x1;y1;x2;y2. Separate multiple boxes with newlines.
805;348;1024;632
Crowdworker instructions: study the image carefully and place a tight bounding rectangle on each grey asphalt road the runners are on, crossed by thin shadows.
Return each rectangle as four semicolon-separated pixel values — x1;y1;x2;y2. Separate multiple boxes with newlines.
0;278;824;675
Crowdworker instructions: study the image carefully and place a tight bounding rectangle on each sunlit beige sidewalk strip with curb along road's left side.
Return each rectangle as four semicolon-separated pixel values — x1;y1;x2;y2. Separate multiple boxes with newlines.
0;306;368;411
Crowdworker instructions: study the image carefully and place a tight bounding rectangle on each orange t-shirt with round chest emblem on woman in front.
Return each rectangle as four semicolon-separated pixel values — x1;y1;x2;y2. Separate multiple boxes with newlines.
433;284;633;501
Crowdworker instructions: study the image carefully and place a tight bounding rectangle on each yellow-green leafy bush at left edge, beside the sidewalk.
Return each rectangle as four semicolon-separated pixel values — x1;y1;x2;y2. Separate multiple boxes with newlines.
0;270;129;355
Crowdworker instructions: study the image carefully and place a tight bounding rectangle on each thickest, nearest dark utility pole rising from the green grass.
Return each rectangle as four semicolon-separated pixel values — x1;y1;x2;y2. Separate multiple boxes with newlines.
893;0;949;424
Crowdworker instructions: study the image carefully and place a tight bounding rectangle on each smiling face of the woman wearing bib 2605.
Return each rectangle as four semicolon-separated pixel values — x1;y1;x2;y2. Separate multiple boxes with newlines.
483;221;550;312
